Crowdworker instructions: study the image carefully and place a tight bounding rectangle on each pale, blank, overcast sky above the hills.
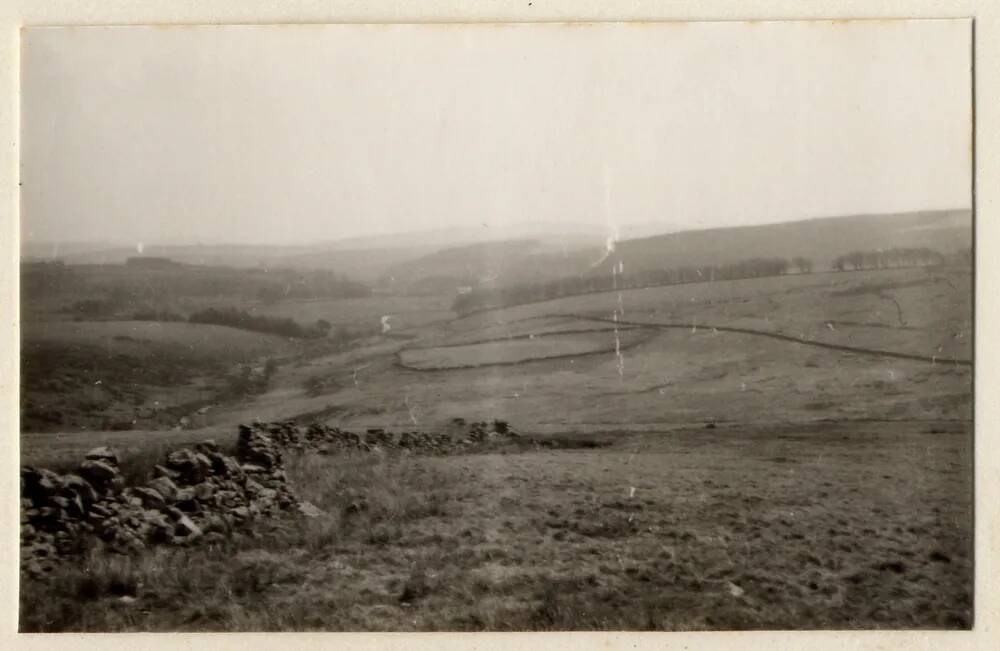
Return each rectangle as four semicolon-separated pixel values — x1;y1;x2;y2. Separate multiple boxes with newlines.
21;21;972;244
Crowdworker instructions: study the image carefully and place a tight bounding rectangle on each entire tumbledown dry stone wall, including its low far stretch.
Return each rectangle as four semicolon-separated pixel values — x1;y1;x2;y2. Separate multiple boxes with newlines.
21;419;540;574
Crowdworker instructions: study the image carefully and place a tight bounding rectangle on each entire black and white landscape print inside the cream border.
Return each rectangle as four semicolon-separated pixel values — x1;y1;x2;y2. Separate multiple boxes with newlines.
12;18;981;633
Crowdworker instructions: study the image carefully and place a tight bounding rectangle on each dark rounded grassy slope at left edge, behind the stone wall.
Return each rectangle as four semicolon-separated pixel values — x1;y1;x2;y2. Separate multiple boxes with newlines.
21;321;296;431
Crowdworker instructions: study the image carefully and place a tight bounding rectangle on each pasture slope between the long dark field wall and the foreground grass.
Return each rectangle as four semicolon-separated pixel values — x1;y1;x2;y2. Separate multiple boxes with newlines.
312;330;972;431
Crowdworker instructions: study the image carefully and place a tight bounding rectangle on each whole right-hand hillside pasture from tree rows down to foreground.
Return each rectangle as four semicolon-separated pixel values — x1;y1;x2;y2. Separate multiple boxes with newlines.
264;269;972;429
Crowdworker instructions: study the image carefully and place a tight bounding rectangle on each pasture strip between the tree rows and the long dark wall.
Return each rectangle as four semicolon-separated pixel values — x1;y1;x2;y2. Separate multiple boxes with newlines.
449;268;972;361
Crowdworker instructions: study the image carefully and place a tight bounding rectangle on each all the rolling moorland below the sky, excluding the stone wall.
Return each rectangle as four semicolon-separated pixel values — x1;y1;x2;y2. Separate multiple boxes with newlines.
21;212;973;630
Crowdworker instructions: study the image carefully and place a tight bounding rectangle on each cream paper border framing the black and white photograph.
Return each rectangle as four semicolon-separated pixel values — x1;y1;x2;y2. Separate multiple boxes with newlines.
0;0;1000;649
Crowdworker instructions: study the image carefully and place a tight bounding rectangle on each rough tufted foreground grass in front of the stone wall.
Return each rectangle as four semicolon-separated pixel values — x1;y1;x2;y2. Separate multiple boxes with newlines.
21;422;972;631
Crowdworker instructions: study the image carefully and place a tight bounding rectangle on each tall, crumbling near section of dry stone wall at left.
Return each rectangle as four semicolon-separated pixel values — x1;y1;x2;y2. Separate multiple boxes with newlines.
21;424;318;574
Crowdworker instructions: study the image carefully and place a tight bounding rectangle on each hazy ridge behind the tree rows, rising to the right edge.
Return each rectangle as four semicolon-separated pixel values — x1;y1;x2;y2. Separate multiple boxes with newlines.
380;210;972;288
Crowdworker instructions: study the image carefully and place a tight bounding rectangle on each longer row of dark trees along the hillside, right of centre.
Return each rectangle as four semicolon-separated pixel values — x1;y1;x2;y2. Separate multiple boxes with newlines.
452;258;813;314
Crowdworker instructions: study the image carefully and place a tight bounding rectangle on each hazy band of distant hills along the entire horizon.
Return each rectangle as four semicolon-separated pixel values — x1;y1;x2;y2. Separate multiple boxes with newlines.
22;210;972;293
